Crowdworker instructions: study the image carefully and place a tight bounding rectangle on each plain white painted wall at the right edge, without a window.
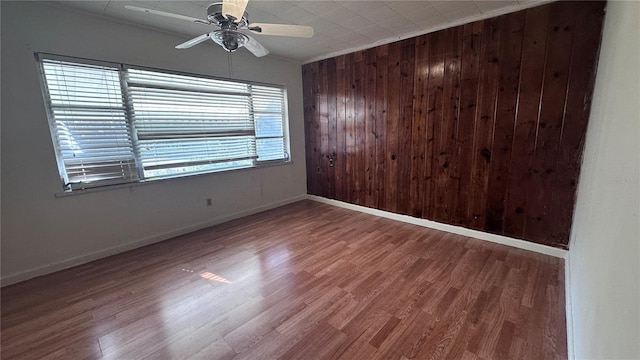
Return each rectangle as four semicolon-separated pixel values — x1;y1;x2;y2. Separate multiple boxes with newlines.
568;1;640;359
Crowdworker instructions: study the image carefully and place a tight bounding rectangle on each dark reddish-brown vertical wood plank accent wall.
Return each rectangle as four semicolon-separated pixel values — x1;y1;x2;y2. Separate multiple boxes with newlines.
303;2;605;248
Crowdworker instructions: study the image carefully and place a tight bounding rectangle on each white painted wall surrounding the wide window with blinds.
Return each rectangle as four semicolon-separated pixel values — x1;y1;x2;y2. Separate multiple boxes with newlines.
1;1;306;285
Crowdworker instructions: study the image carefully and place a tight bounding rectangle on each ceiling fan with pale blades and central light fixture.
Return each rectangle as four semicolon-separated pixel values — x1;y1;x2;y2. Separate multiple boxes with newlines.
125;0;313;57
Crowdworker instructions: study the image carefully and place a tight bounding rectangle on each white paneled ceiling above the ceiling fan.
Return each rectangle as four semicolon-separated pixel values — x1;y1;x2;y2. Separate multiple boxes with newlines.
56;0;548;63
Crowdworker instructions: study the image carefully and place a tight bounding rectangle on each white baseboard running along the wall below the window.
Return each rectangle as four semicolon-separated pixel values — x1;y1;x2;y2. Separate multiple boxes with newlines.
0;195;307;286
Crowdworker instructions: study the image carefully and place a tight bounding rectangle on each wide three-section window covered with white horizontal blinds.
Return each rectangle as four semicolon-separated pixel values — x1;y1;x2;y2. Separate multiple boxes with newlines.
37;54;289;190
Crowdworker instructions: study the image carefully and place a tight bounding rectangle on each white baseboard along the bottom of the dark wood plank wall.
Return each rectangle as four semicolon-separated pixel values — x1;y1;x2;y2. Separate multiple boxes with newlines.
307;195;569;259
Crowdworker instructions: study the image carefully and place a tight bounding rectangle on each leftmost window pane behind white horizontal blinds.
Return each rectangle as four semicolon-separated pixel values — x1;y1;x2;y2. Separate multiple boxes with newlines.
42;59;138;188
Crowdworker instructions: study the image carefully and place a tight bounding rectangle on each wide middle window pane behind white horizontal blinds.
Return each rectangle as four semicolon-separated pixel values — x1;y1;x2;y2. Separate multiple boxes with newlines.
127;69;256;177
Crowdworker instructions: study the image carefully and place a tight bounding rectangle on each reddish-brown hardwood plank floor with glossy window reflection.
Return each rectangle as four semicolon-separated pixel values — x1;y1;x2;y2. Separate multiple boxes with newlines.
1;201;567;359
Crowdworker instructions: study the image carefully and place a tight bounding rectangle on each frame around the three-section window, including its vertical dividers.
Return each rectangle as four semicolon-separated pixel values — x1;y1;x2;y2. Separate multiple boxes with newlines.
34;52;293;195
